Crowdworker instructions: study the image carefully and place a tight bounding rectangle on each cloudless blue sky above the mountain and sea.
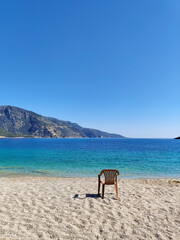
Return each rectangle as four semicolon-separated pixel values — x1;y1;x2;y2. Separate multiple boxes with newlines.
0;0;180;138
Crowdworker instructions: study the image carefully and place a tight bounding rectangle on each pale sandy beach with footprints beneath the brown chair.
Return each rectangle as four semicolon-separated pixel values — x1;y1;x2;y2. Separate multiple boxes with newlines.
0;177;180;240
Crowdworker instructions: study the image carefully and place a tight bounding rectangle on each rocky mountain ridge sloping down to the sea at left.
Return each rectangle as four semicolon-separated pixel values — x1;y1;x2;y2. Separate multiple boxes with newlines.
0;106;124;138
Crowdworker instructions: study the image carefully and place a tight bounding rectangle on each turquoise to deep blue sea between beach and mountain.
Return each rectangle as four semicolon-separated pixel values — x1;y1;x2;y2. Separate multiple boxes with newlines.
0;139;180;178
